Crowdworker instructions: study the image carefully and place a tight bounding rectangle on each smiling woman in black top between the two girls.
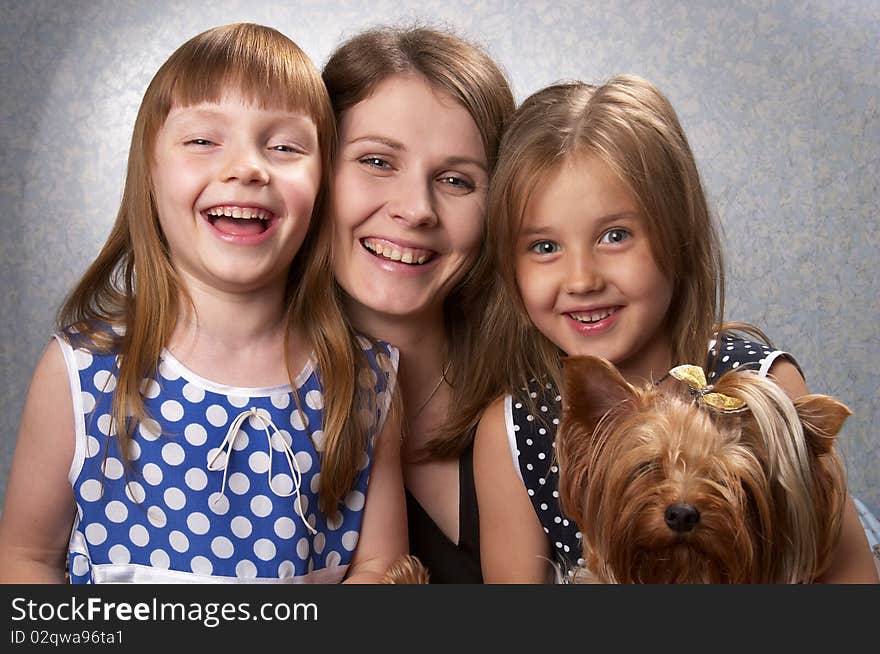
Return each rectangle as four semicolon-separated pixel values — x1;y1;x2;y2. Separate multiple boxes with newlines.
323;27;514;583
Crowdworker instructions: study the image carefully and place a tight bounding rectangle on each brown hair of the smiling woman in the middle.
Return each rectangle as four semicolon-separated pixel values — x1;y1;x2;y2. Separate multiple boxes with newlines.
323;27;515;457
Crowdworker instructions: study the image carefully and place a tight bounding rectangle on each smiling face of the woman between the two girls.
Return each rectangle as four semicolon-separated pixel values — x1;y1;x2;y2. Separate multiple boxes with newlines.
333;75;489;328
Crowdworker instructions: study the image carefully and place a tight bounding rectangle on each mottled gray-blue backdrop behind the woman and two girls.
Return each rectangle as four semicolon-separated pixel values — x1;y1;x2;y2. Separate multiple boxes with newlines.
0;0;880;515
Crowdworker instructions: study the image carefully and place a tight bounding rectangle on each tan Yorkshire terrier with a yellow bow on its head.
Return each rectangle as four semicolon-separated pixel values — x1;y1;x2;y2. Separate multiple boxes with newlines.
556;357;851;584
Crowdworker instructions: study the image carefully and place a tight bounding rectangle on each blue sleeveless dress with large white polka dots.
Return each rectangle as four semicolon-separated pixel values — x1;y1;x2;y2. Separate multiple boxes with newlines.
56;335;397;583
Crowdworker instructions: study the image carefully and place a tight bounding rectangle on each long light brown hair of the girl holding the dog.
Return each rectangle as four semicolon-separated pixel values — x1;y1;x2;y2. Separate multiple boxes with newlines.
473;75;724;404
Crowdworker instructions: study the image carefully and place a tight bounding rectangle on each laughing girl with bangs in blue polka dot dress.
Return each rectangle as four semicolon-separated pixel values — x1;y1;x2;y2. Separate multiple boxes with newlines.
0;24;406;583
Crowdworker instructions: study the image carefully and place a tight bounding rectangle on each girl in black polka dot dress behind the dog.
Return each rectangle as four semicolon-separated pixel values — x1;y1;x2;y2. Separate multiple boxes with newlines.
474;75;876;582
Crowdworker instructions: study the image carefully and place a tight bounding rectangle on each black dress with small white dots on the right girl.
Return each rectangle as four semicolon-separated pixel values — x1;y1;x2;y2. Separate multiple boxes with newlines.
504;334;797;570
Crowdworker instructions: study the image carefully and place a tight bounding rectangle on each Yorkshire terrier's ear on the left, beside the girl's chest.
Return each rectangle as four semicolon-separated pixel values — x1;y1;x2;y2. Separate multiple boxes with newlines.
562;356;635;424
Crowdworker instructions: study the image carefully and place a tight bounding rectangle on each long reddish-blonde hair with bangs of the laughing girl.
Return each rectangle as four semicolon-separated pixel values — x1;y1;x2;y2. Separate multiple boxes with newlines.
57;23;365;514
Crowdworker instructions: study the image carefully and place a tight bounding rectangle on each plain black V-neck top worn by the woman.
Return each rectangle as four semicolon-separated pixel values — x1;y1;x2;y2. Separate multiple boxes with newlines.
406;439;483;584
